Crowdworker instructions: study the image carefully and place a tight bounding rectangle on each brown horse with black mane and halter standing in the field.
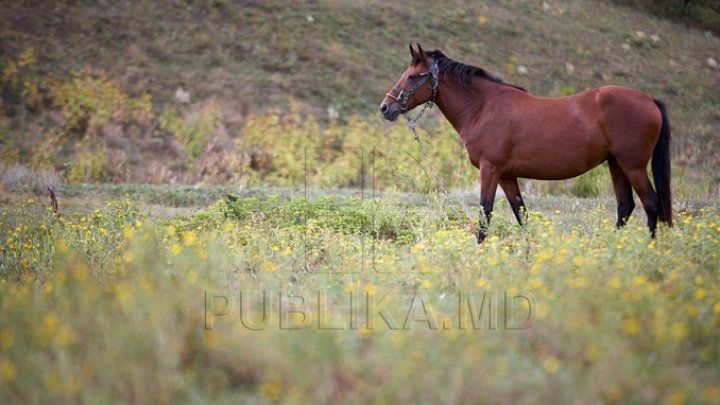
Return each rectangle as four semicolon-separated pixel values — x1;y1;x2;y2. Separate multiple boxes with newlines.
380;45;672;243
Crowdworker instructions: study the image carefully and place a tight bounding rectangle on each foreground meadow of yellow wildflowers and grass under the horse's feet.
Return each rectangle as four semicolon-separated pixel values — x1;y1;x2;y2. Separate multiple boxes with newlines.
0;189;720;404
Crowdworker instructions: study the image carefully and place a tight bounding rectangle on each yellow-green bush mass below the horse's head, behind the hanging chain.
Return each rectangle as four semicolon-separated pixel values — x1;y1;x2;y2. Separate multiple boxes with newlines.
237;101;477;192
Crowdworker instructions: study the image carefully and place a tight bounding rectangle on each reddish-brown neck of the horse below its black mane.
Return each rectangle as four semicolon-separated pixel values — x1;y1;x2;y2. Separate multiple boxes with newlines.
430;78;507;137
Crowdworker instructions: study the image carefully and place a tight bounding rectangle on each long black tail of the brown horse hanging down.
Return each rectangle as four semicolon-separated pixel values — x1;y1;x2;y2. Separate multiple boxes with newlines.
651;100;672;226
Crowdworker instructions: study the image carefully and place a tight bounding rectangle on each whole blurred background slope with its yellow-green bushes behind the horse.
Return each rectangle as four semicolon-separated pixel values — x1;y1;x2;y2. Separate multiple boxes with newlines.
0;0;720;196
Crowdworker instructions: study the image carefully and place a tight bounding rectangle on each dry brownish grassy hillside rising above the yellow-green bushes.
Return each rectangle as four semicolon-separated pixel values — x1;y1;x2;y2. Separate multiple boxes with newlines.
0;0;720;188
